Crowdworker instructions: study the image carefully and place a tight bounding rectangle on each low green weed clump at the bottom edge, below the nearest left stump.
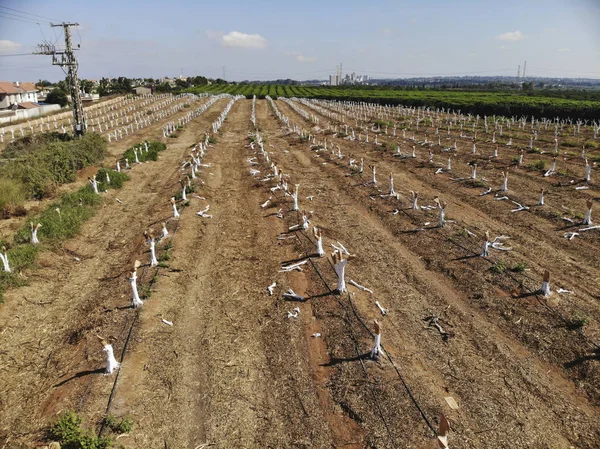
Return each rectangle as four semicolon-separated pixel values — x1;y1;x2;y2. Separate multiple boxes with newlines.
50;411;113;449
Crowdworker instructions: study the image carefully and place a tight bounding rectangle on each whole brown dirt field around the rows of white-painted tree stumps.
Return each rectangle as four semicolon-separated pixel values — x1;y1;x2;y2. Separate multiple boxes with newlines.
0;99;600;449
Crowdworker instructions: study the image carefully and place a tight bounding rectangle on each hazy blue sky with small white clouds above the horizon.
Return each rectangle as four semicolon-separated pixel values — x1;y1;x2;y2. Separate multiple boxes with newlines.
0;0;600;81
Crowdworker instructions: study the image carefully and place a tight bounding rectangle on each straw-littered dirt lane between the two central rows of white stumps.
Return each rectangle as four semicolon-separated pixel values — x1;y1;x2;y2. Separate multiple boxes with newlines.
109;96;356;448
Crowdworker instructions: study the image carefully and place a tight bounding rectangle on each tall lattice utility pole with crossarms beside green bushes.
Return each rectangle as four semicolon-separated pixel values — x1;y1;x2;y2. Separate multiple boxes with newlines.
34;22;87;136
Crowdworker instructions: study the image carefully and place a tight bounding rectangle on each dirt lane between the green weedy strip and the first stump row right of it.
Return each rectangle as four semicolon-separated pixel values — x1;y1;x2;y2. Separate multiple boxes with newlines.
0;100;226;447
